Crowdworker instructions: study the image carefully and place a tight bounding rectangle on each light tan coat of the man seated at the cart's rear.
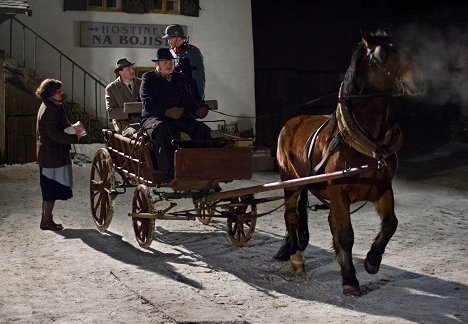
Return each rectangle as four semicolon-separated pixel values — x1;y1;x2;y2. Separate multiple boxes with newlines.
106;77;141;120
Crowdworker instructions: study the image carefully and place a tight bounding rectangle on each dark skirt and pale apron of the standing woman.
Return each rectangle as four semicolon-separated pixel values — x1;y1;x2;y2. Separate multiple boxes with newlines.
40;164;73;201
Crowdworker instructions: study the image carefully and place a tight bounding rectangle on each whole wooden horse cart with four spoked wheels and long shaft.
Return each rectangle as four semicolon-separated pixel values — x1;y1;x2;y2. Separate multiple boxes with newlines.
90;129;367;248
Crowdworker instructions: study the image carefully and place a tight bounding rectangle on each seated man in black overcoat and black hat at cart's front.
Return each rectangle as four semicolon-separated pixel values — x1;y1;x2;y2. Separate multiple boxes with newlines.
140;48;211;182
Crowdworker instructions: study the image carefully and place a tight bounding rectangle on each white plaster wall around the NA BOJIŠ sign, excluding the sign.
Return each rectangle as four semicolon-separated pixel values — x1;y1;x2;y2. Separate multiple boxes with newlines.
0;0;255;131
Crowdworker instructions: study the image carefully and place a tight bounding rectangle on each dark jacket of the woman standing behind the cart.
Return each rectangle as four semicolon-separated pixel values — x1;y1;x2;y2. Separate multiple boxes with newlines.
36;100;78;168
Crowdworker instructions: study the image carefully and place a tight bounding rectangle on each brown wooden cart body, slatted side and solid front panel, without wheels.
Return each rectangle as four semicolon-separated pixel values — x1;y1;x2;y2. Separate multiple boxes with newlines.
103;129;252;191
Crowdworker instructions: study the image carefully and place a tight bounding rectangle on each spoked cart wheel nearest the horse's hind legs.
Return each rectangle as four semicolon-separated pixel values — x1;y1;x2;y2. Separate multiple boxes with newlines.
227;195;257;247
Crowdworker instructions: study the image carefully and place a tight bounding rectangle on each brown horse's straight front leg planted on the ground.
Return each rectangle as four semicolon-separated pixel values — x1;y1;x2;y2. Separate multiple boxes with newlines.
328;190;362;296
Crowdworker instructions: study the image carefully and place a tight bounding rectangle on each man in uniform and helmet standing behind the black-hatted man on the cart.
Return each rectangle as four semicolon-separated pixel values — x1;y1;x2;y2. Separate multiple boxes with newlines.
163;24;205;100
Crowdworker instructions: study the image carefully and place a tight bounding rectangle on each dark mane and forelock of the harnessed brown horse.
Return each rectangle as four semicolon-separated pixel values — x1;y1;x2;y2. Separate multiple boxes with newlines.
342;30;391;95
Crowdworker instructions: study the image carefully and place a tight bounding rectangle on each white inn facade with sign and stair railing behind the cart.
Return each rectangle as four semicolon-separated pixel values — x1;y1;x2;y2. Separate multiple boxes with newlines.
0;0;255;131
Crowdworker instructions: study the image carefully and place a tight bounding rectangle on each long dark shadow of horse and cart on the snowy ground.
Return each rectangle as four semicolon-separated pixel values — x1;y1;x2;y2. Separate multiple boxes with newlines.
164;228;468;323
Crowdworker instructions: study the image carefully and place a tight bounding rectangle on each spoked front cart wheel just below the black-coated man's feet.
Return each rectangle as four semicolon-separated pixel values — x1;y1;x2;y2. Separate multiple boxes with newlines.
132;184;154;249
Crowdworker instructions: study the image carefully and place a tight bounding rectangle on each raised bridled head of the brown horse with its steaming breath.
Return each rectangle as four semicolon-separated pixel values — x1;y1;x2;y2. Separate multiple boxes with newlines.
361;30;425;96
